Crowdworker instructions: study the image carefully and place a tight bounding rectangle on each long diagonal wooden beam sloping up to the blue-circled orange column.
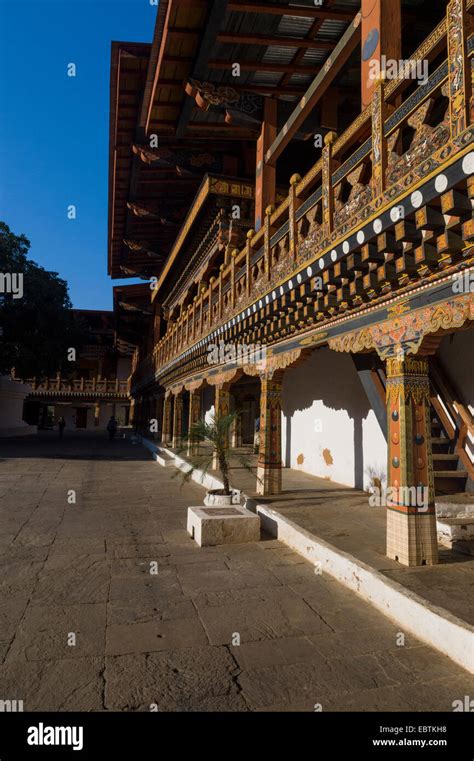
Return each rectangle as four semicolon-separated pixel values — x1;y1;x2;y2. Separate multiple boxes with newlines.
265;13;361;165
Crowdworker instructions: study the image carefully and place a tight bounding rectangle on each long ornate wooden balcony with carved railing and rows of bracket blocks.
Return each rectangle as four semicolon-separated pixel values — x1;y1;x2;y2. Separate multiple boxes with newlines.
132;4;474;394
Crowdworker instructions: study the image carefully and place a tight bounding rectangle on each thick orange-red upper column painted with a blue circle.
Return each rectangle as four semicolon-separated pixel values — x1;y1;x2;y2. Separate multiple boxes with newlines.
361;0;402;110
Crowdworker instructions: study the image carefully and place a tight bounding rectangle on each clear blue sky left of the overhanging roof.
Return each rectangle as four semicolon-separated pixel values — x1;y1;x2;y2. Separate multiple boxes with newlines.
0;0;156;309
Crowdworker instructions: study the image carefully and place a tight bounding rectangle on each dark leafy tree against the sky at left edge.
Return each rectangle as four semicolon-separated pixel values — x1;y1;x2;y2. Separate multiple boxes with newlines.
0;222;80;378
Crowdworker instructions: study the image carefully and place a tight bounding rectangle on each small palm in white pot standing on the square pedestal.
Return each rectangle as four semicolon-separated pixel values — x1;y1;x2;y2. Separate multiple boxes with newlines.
175;412;254;507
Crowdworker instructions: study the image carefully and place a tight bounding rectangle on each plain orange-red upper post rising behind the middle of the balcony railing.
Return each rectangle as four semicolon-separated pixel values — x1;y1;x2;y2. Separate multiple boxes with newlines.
255;98;278;232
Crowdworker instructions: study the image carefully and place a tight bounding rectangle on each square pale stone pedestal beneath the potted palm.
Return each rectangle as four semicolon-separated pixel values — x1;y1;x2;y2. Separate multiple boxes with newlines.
187;505;260;547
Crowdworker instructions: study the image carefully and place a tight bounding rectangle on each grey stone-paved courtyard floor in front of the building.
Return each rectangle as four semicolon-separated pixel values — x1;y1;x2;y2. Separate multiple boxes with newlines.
0;433;473;711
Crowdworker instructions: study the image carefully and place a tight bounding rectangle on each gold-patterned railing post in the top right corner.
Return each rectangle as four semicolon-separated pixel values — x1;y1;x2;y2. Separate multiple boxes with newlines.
447;0;474;138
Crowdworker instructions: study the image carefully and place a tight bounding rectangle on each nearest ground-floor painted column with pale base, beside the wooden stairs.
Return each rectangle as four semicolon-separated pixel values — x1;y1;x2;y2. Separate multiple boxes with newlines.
386;355;438;566
